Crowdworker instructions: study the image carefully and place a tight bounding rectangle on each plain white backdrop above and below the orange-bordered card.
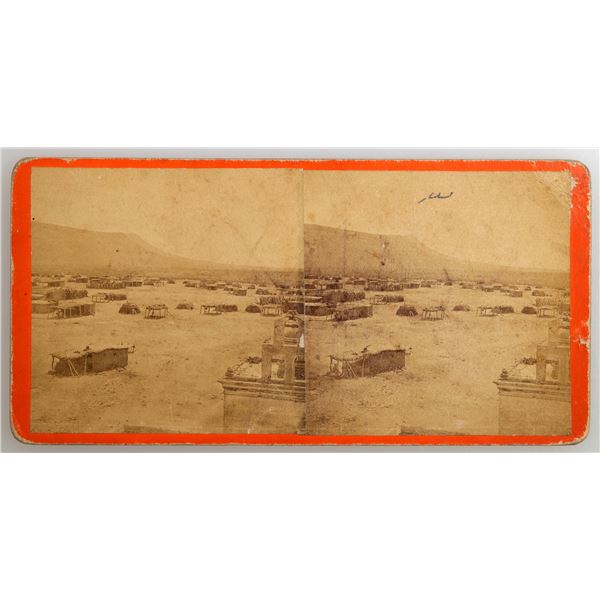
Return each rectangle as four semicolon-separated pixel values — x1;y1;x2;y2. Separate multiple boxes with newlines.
0;0;600;600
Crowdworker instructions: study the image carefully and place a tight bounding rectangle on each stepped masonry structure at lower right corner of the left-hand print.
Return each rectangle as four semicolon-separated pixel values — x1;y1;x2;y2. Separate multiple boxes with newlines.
220;312;305;433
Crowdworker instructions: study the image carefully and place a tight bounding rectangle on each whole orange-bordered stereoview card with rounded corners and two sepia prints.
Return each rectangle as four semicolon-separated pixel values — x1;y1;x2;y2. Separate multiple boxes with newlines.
11;159;590;445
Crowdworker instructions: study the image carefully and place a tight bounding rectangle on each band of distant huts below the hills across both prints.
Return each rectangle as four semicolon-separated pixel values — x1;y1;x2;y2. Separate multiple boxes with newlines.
33;274;569;321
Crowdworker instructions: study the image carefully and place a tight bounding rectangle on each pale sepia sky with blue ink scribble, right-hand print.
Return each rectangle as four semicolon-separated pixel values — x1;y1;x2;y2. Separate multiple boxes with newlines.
304;171;571;271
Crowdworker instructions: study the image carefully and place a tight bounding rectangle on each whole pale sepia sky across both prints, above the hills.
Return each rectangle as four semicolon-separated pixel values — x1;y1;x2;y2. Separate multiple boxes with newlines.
32;167;571;270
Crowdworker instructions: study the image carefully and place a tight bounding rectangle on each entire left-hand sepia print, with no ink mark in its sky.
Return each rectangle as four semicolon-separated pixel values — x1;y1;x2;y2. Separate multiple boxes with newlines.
30;166;305;434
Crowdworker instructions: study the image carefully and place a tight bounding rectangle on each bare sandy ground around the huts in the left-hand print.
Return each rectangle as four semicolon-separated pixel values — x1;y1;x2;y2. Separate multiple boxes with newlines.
31;281;273;433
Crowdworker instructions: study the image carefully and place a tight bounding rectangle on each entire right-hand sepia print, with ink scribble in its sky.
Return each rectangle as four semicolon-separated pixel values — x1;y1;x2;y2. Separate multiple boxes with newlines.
303;169;573;436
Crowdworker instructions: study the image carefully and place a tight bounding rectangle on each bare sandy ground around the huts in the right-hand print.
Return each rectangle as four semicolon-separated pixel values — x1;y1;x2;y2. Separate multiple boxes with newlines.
306;285;568;435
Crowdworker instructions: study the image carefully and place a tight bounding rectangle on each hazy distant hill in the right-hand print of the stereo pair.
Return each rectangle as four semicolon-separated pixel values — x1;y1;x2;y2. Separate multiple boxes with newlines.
304;225;569;287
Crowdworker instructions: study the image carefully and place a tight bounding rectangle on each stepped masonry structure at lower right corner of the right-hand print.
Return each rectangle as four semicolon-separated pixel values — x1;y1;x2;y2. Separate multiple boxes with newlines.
494;319;571;435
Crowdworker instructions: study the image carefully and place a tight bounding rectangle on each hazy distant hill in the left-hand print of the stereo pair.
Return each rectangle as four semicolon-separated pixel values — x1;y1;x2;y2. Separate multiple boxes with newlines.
31;221;300;284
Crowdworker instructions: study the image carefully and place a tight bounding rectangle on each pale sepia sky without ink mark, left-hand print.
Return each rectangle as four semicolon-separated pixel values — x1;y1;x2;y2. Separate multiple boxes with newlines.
31;167;304;268
